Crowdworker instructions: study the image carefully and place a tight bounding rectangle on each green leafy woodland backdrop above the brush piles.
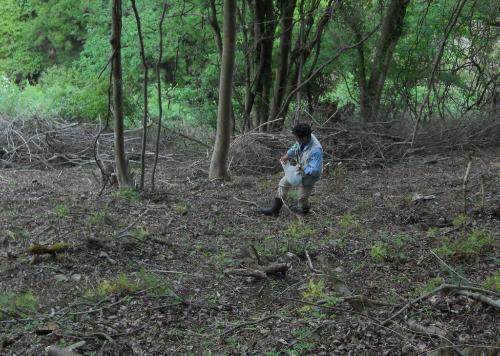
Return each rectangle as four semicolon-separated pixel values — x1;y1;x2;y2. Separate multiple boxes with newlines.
0;0;500;131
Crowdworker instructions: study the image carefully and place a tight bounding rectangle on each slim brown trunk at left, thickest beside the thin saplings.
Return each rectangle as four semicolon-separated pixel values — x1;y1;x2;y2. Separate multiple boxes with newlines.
110;0;132;188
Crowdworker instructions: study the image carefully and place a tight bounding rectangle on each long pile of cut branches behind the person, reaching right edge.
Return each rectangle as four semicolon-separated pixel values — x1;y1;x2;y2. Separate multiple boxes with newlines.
229;114;500;174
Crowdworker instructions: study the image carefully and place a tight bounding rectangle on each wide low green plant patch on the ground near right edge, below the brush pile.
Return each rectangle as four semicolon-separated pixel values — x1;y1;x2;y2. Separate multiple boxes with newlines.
434;230;495;258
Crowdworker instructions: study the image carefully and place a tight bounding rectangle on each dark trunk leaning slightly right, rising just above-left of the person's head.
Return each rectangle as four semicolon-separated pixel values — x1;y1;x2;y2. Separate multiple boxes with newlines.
268;0;296;130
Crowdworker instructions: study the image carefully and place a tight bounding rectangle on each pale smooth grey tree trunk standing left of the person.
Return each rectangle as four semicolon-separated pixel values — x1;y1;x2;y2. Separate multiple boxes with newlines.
209;0;236;180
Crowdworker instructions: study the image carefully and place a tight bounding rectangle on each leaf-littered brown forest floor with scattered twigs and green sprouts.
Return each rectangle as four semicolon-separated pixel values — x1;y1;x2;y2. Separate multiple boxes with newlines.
0;148;500;355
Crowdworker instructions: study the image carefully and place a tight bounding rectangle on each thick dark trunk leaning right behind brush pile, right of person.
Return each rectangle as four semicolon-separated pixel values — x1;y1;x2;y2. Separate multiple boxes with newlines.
360;0;410;121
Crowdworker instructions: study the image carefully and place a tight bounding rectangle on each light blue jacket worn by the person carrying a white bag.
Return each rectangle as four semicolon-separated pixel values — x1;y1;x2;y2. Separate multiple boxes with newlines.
287;135;323;186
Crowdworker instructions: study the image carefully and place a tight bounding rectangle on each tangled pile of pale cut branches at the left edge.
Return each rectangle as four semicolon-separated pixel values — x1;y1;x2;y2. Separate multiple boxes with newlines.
0;118;174;169
